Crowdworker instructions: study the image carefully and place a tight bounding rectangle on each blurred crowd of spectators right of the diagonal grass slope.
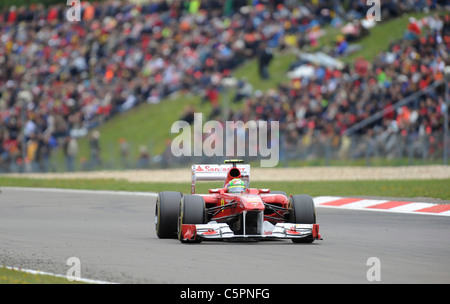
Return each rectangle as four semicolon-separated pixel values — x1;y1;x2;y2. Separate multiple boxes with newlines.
231;14;450;163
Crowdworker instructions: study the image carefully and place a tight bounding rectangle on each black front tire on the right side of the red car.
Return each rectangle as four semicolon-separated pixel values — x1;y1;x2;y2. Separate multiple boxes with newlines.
289;194;316;243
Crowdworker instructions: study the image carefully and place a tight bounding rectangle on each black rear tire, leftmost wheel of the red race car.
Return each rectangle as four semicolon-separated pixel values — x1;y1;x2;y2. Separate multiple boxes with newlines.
155;191;183;239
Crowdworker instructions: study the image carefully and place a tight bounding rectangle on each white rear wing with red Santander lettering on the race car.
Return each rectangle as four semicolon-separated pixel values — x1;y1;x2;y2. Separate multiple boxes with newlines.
191;164;250;194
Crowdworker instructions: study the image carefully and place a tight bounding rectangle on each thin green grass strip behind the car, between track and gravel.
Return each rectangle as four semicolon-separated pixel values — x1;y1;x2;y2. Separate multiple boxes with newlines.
0;177;450;200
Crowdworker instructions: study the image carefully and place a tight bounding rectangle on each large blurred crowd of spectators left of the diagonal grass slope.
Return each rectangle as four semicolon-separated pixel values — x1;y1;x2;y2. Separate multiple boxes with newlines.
0;0;282;171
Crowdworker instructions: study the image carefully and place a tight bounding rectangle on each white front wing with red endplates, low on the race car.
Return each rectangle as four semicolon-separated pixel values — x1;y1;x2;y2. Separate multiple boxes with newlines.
180;221;322;242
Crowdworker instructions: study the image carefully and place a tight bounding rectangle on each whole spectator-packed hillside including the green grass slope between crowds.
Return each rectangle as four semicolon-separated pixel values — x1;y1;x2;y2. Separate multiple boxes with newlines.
0;0;450;173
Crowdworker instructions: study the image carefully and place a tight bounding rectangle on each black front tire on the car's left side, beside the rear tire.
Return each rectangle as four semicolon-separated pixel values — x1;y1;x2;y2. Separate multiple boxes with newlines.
177;195;206;243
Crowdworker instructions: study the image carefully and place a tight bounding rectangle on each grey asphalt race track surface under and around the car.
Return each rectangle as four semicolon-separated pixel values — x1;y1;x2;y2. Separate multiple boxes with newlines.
0;188;450;284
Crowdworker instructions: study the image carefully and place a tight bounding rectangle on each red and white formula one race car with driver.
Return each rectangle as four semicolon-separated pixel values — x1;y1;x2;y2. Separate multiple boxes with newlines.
155;160;322;243
